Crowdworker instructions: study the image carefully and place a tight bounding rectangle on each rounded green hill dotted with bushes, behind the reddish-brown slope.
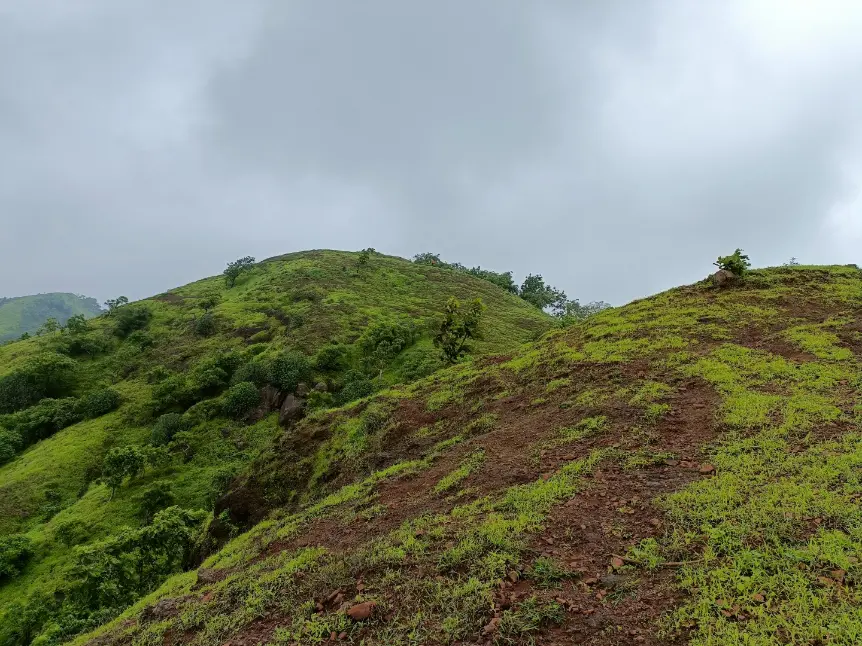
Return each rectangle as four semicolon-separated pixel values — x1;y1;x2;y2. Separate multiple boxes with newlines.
0;251;553;645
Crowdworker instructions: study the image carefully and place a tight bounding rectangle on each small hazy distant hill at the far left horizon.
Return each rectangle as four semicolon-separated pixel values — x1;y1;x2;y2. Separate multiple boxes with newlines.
0;293;102;343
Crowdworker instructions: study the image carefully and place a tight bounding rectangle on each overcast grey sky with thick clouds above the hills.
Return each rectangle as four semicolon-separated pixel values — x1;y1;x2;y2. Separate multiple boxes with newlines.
0;0;862;304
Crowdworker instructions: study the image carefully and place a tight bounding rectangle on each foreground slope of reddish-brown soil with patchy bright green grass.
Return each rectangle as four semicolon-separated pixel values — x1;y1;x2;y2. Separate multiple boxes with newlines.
69;266;862;646
